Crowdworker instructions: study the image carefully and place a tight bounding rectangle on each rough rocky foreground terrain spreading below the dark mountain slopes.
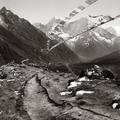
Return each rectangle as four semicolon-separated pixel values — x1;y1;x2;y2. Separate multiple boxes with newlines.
0;63;120;120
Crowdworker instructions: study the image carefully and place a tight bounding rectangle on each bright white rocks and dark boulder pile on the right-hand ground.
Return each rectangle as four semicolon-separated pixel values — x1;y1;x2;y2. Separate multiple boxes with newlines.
60;65;114;98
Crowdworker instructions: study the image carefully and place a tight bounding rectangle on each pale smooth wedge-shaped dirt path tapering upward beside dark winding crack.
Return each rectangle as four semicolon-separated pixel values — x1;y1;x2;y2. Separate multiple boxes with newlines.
24;74;59;120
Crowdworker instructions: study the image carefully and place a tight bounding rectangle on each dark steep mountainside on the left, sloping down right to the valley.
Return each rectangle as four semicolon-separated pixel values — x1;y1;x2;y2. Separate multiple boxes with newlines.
0;7;79;64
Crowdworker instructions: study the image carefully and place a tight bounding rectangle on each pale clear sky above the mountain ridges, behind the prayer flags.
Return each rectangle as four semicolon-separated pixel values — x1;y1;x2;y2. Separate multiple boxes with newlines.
0;0;120;32
